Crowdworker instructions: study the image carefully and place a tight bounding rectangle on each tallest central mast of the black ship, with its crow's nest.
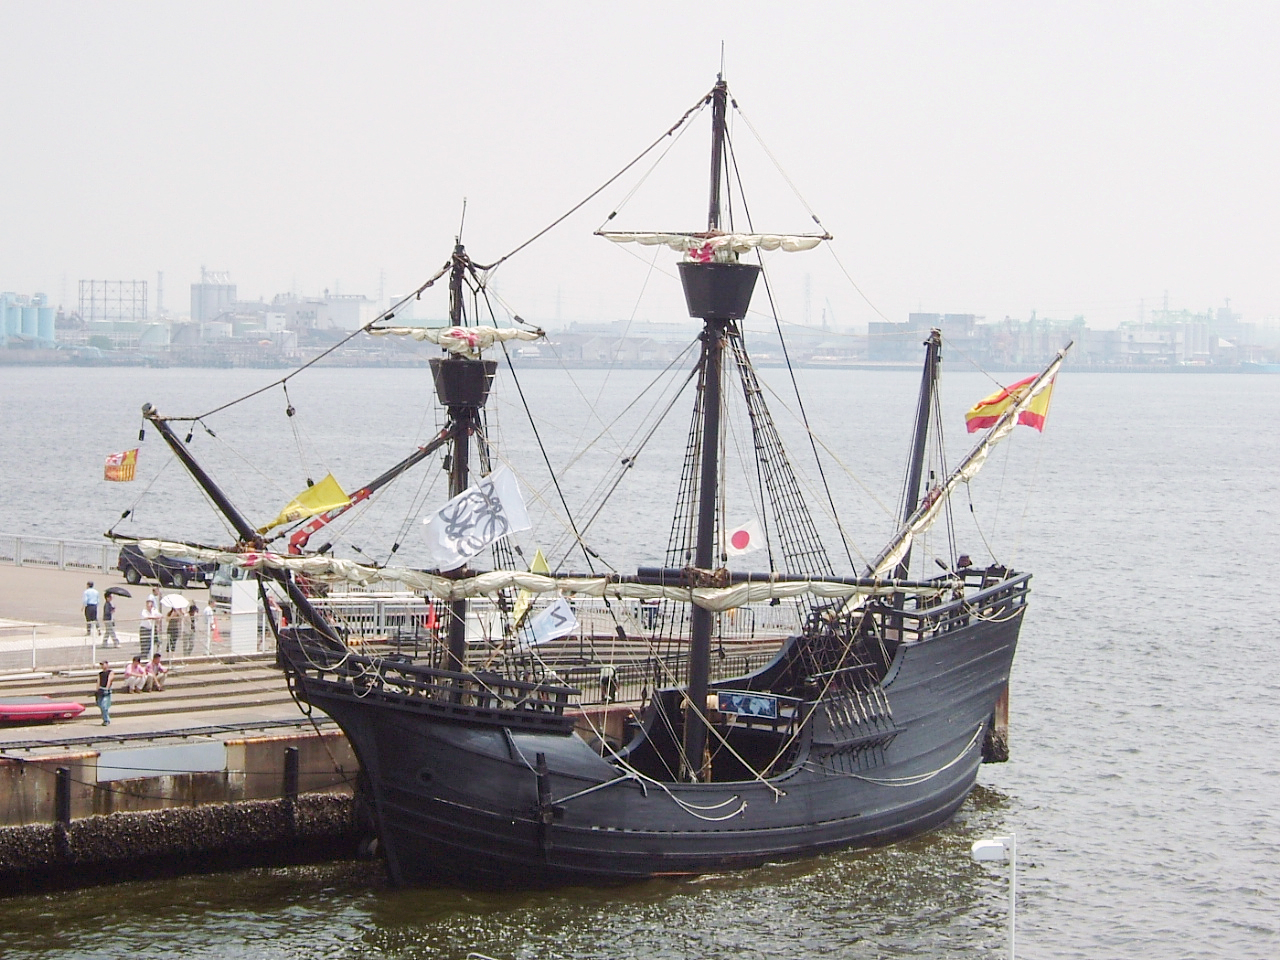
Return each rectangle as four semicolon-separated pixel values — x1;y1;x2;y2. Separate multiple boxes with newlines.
680;77;760;781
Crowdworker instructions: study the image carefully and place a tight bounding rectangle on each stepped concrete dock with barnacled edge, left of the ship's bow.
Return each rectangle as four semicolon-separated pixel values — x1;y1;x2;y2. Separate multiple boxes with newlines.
0;566;369;892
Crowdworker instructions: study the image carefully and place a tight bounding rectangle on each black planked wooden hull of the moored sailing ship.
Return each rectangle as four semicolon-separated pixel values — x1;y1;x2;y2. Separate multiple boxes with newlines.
294;607;1023;888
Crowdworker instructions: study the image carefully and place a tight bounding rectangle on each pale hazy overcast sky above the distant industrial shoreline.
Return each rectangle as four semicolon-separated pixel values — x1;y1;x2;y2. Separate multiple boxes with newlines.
0;0;1280;328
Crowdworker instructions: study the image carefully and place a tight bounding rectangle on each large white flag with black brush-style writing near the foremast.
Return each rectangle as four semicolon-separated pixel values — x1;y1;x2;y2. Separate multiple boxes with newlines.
422;467;532;570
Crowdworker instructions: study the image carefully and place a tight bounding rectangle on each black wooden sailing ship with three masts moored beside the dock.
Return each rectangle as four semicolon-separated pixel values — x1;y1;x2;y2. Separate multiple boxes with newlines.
135;79;1062;888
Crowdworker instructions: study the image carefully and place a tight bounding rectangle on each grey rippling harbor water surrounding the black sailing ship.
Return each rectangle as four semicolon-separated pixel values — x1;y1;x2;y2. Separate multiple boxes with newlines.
0;367;1280;960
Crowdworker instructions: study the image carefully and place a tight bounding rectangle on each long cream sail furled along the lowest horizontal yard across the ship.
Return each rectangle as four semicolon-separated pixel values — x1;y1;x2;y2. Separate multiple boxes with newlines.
127;540;951;612
